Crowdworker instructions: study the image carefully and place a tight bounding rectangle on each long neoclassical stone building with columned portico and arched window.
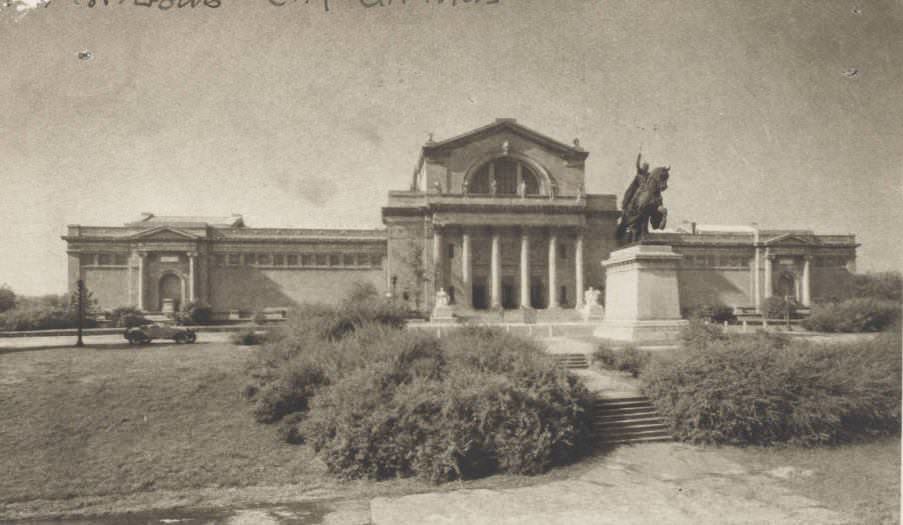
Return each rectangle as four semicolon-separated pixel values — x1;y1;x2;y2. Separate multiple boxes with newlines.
63;119;858;319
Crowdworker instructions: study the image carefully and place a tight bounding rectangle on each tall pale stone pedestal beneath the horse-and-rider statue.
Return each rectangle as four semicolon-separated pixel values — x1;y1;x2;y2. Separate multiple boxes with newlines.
593;244;688;343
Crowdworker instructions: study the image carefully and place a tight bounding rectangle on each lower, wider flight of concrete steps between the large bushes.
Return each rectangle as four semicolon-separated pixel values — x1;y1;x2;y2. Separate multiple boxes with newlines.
592;396;673;446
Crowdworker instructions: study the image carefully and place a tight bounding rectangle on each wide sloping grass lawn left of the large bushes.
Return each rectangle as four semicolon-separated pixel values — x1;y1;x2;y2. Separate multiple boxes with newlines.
0;344;334;503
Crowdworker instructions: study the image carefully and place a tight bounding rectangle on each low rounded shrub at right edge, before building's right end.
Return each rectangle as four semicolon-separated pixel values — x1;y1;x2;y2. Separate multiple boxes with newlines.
803;298;900;332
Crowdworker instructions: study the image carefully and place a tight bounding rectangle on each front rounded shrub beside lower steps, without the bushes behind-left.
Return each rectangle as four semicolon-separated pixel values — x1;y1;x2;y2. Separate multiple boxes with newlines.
300;329;589;482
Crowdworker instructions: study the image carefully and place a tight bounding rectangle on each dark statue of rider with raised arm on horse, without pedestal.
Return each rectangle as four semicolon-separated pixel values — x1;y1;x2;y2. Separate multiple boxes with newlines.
616;153;671;242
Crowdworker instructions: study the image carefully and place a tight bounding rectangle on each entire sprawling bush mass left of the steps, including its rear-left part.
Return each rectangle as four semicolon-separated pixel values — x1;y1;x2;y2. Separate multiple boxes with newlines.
246;292;590;482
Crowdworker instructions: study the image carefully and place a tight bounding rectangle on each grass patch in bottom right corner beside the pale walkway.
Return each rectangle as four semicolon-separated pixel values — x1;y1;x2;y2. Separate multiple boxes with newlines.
718;437;900;524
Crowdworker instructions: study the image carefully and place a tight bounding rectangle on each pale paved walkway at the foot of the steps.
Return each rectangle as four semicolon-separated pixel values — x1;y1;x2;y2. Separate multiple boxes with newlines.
370;443;855;525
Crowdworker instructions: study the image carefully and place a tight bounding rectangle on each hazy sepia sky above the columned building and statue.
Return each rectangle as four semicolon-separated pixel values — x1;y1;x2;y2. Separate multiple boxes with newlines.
0;0;903;295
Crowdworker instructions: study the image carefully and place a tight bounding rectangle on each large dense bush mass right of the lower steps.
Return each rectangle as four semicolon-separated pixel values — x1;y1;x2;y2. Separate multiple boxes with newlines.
643;326;903;445
